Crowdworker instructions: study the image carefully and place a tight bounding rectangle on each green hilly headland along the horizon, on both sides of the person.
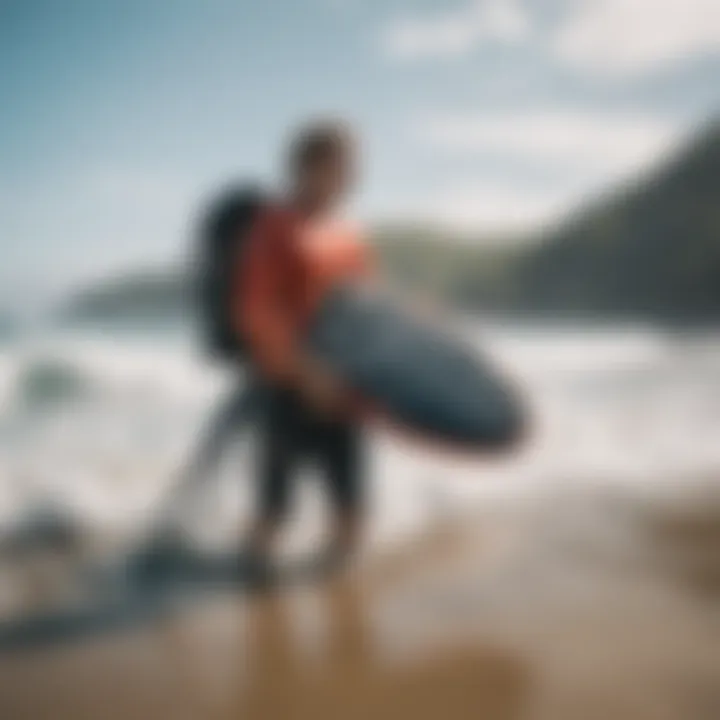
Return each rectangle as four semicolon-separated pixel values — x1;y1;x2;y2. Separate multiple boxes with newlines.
62;123;720;321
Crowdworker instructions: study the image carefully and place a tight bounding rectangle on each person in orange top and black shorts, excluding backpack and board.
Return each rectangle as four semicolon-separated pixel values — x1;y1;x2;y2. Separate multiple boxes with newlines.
239;121;372;572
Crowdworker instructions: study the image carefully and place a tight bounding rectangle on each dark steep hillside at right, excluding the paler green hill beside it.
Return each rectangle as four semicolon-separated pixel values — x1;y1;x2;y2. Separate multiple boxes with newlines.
516;123;720;318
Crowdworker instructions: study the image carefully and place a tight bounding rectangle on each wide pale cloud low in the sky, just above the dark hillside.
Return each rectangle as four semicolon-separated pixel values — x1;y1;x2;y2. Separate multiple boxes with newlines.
408;109;689;231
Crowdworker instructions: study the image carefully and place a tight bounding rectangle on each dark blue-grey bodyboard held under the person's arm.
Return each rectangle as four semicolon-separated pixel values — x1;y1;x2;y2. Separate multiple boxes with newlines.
305;283;524;450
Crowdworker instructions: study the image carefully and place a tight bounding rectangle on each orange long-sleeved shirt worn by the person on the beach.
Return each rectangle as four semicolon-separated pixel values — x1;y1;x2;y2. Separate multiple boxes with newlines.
236;207;372;376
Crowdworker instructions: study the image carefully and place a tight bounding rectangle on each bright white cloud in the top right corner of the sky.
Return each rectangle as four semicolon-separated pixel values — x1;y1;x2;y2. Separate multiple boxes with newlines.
552;0;720;77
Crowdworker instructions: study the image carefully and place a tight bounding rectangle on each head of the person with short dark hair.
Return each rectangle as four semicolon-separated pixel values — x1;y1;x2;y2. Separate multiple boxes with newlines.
287;120;356;212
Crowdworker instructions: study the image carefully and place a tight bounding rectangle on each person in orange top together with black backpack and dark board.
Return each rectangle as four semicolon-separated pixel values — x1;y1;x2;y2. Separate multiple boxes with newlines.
153;116;526;580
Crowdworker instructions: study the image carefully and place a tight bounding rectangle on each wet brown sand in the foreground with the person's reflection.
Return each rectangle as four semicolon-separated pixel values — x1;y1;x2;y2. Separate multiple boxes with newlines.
0;489;720;720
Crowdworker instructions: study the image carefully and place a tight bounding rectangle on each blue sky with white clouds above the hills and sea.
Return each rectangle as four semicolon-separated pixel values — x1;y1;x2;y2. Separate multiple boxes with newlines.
0;0;720;301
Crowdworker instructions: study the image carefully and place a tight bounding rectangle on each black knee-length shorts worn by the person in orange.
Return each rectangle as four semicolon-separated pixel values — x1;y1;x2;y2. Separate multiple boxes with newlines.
257;389;364;520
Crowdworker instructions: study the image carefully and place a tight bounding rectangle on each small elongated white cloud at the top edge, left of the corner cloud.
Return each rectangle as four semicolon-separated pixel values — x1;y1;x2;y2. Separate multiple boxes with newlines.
384;0;531;60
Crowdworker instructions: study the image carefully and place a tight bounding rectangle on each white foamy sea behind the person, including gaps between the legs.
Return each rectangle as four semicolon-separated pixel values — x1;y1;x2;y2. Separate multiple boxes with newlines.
0;320;720;556
